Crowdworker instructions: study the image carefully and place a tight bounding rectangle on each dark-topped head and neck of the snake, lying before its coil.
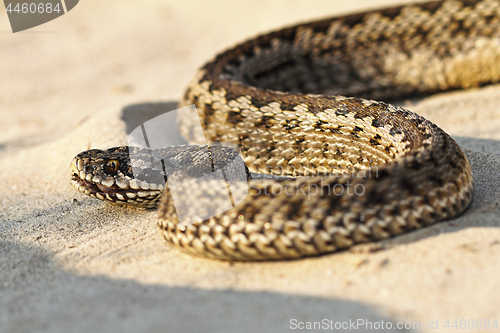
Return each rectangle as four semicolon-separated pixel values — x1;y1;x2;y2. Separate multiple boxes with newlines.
70;145;250;208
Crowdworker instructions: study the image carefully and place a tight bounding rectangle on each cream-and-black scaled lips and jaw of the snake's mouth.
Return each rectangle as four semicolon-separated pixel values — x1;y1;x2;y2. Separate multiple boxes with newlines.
70;158;163;208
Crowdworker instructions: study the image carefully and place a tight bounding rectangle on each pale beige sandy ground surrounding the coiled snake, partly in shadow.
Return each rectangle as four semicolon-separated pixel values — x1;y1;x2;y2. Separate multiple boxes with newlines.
0;0;500;332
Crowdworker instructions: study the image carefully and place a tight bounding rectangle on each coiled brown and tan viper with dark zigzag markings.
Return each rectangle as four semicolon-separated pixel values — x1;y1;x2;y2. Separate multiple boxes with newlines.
70;0;500;261
